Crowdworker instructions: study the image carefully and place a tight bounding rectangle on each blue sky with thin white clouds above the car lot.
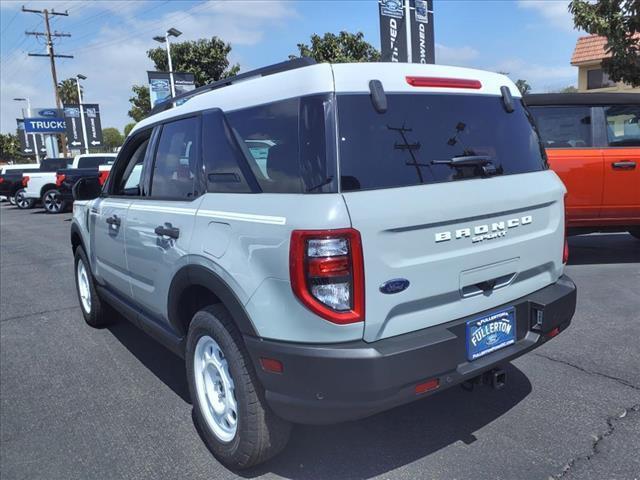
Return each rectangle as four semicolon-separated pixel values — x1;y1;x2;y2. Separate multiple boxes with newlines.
0;0;584;132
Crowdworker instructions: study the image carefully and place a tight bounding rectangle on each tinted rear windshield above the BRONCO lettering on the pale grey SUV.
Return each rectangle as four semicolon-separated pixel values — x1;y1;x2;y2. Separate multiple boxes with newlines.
337;94;547;191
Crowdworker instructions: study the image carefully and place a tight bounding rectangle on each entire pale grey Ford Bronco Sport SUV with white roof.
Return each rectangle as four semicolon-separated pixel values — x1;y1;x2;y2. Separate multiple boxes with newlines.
71;59;576;468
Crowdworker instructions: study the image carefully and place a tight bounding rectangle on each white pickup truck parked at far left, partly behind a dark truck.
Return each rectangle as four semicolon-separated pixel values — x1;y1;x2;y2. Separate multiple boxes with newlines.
24;153;116;213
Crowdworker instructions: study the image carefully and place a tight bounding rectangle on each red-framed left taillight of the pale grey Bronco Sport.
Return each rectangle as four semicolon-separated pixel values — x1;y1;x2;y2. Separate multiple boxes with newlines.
289;228;364;324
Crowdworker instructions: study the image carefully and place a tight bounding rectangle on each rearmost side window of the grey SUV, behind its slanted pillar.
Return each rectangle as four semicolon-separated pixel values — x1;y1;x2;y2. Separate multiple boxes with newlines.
226;95;337;193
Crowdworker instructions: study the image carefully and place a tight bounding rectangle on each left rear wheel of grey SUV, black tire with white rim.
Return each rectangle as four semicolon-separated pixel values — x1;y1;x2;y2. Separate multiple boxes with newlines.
185;305;291;469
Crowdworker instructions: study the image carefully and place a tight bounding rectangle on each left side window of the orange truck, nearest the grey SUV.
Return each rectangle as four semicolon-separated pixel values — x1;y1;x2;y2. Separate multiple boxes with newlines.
531;106;593;148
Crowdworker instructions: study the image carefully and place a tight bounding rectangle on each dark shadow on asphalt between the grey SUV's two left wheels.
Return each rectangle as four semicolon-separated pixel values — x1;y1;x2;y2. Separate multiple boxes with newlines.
107;318;191;403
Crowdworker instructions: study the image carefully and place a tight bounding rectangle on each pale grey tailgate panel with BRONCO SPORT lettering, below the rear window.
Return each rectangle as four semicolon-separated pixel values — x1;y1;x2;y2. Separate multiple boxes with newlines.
343;170;565;342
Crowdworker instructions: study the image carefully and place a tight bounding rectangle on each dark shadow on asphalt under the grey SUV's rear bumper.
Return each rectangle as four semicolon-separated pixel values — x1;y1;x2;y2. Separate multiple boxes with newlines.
242;364;532;480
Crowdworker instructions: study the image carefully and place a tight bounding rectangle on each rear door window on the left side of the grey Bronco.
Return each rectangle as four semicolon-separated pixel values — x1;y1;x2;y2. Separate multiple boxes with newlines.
151;117;200;200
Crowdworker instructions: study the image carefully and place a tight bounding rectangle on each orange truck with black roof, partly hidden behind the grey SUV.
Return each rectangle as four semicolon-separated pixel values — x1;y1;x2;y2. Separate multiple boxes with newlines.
525;93;640;239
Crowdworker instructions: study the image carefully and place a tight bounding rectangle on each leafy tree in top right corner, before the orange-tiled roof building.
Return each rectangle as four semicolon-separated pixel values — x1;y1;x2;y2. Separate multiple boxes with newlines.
569;0;640;87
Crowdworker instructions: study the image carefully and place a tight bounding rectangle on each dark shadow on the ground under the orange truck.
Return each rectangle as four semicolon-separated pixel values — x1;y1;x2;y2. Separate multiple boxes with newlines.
569;233;640;265
